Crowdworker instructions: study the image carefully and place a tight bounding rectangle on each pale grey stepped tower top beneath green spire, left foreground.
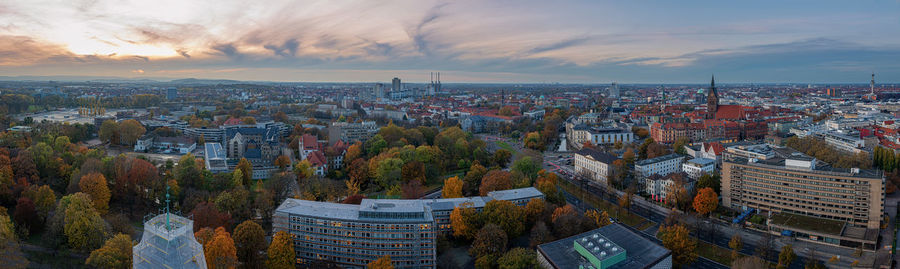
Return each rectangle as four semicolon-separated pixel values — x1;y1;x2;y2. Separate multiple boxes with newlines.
131;206;206;269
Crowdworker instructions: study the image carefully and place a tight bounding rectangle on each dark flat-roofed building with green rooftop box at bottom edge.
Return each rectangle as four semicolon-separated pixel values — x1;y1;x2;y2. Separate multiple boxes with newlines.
537;223;672;269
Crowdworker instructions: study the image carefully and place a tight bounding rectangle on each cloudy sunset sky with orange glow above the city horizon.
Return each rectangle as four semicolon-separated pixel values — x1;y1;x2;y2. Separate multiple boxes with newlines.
0;0;900;83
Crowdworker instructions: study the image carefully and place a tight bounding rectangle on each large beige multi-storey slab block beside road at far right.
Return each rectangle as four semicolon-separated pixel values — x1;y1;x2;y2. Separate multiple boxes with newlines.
722;148;885;250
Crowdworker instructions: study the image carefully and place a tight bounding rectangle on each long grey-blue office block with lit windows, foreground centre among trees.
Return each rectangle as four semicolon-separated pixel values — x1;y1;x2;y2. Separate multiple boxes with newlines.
273;188;543;268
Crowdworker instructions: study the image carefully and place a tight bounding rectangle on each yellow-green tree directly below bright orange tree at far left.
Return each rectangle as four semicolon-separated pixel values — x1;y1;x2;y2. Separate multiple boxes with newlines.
57;192;106;250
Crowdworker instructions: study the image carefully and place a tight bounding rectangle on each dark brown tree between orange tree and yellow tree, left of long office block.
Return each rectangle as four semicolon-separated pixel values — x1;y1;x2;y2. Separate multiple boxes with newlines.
234;220;266;268
